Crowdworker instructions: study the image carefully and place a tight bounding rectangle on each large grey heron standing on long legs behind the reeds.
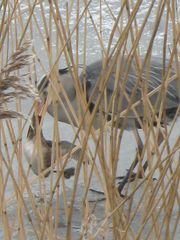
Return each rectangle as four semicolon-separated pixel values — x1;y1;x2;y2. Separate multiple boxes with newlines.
39;56;180;194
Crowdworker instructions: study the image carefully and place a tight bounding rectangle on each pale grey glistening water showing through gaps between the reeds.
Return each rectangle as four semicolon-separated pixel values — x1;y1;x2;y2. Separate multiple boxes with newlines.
0;0;180;240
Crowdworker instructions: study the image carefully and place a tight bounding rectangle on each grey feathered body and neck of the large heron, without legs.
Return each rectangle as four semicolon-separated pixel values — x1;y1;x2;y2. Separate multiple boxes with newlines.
40;57;180;129
